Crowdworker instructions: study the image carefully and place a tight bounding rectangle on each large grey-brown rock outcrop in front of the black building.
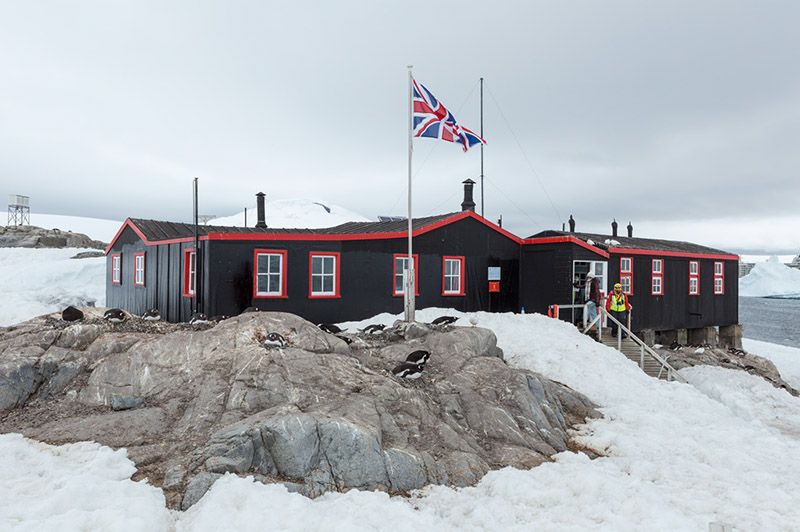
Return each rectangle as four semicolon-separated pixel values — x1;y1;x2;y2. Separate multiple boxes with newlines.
0;309;598;509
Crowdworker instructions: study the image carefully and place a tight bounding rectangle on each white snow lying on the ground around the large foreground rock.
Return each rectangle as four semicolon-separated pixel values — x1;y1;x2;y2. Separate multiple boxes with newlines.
0;211;800;532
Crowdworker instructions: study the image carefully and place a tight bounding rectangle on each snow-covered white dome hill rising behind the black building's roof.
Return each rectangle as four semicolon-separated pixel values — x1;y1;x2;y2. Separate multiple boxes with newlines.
208;199;370;229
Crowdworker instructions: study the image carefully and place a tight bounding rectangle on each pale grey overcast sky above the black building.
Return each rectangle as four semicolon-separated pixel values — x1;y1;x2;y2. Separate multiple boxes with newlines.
0;0;800;254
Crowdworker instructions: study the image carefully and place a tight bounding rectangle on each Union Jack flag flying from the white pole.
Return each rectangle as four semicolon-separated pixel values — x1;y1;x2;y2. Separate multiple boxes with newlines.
412;80;486;151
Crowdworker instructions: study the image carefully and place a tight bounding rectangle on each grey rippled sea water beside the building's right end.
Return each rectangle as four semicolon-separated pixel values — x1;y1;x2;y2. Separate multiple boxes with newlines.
739;297;800;348
